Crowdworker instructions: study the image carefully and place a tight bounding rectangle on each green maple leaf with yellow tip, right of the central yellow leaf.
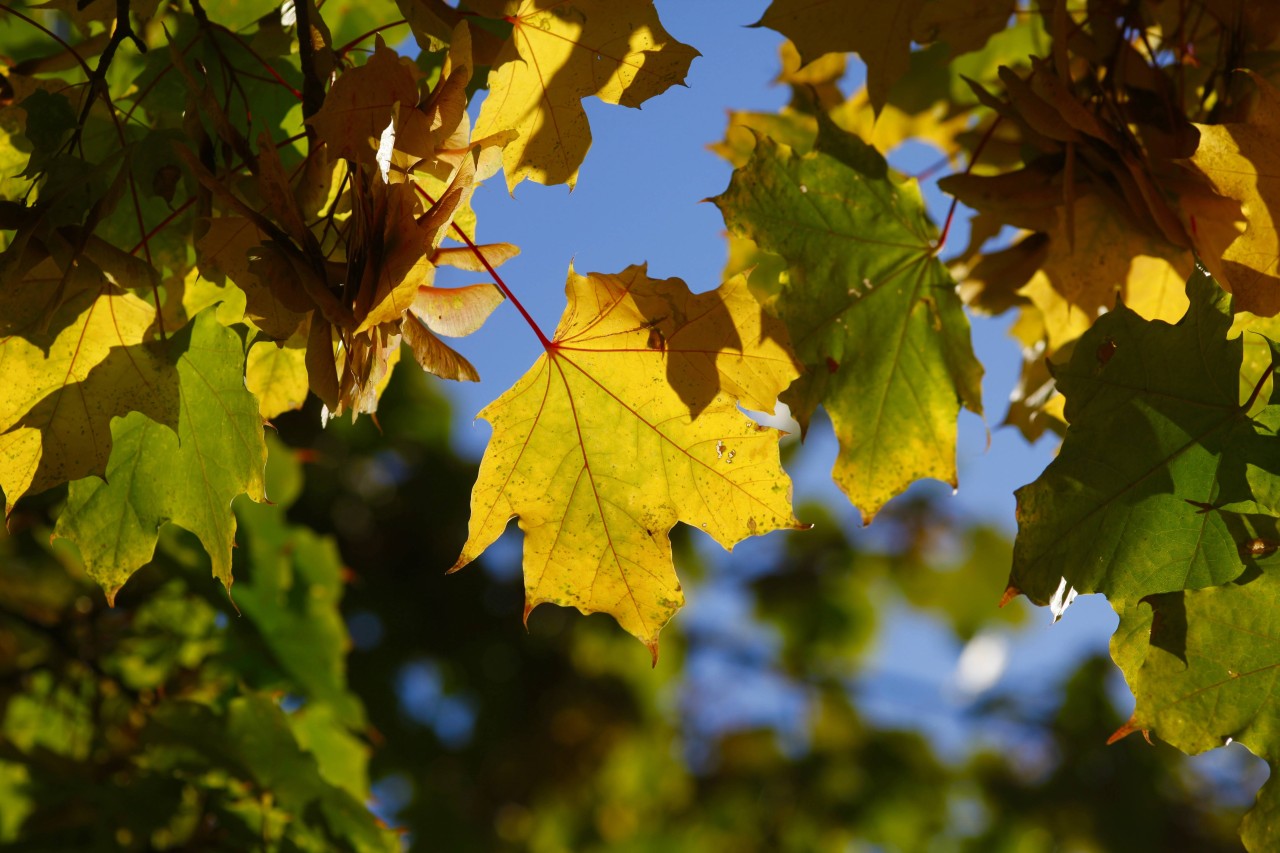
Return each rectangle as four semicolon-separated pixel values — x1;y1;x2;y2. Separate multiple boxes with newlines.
713;118;982;521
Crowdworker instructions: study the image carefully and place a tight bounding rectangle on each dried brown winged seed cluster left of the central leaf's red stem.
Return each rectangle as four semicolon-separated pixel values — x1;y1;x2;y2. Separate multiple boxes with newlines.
187;24;516;416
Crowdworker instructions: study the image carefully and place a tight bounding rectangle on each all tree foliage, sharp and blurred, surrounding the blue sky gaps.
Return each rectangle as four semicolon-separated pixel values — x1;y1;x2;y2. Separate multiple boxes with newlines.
0;0;1280;850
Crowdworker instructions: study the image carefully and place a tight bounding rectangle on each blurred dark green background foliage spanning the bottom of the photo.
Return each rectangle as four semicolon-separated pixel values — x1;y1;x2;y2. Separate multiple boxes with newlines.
0;363;1243;853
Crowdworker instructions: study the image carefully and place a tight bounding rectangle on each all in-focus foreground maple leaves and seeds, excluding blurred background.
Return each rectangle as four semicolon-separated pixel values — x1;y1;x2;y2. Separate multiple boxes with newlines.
0;0;1280;849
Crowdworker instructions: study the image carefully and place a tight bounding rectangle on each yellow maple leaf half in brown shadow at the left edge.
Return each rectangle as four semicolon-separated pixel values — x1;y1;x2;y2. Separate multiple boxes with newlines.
0;282;178;512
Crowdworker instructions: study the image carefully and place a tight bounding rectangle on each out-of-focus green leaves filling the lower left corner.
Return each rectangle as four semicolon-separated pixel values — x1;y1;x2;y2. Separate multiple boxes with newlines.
0;435;398;850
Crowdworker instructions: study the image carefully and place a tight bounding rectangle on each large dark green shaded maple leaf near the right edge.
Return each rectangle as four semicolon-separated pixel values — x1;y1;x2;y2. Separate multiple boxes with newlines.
1010;272;1280;610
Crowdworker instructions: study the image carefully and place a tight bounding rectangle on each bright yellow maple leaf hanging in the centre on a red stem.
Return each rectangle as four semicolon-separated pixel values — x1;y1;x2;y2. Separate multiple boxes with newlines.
453;266;804;650
